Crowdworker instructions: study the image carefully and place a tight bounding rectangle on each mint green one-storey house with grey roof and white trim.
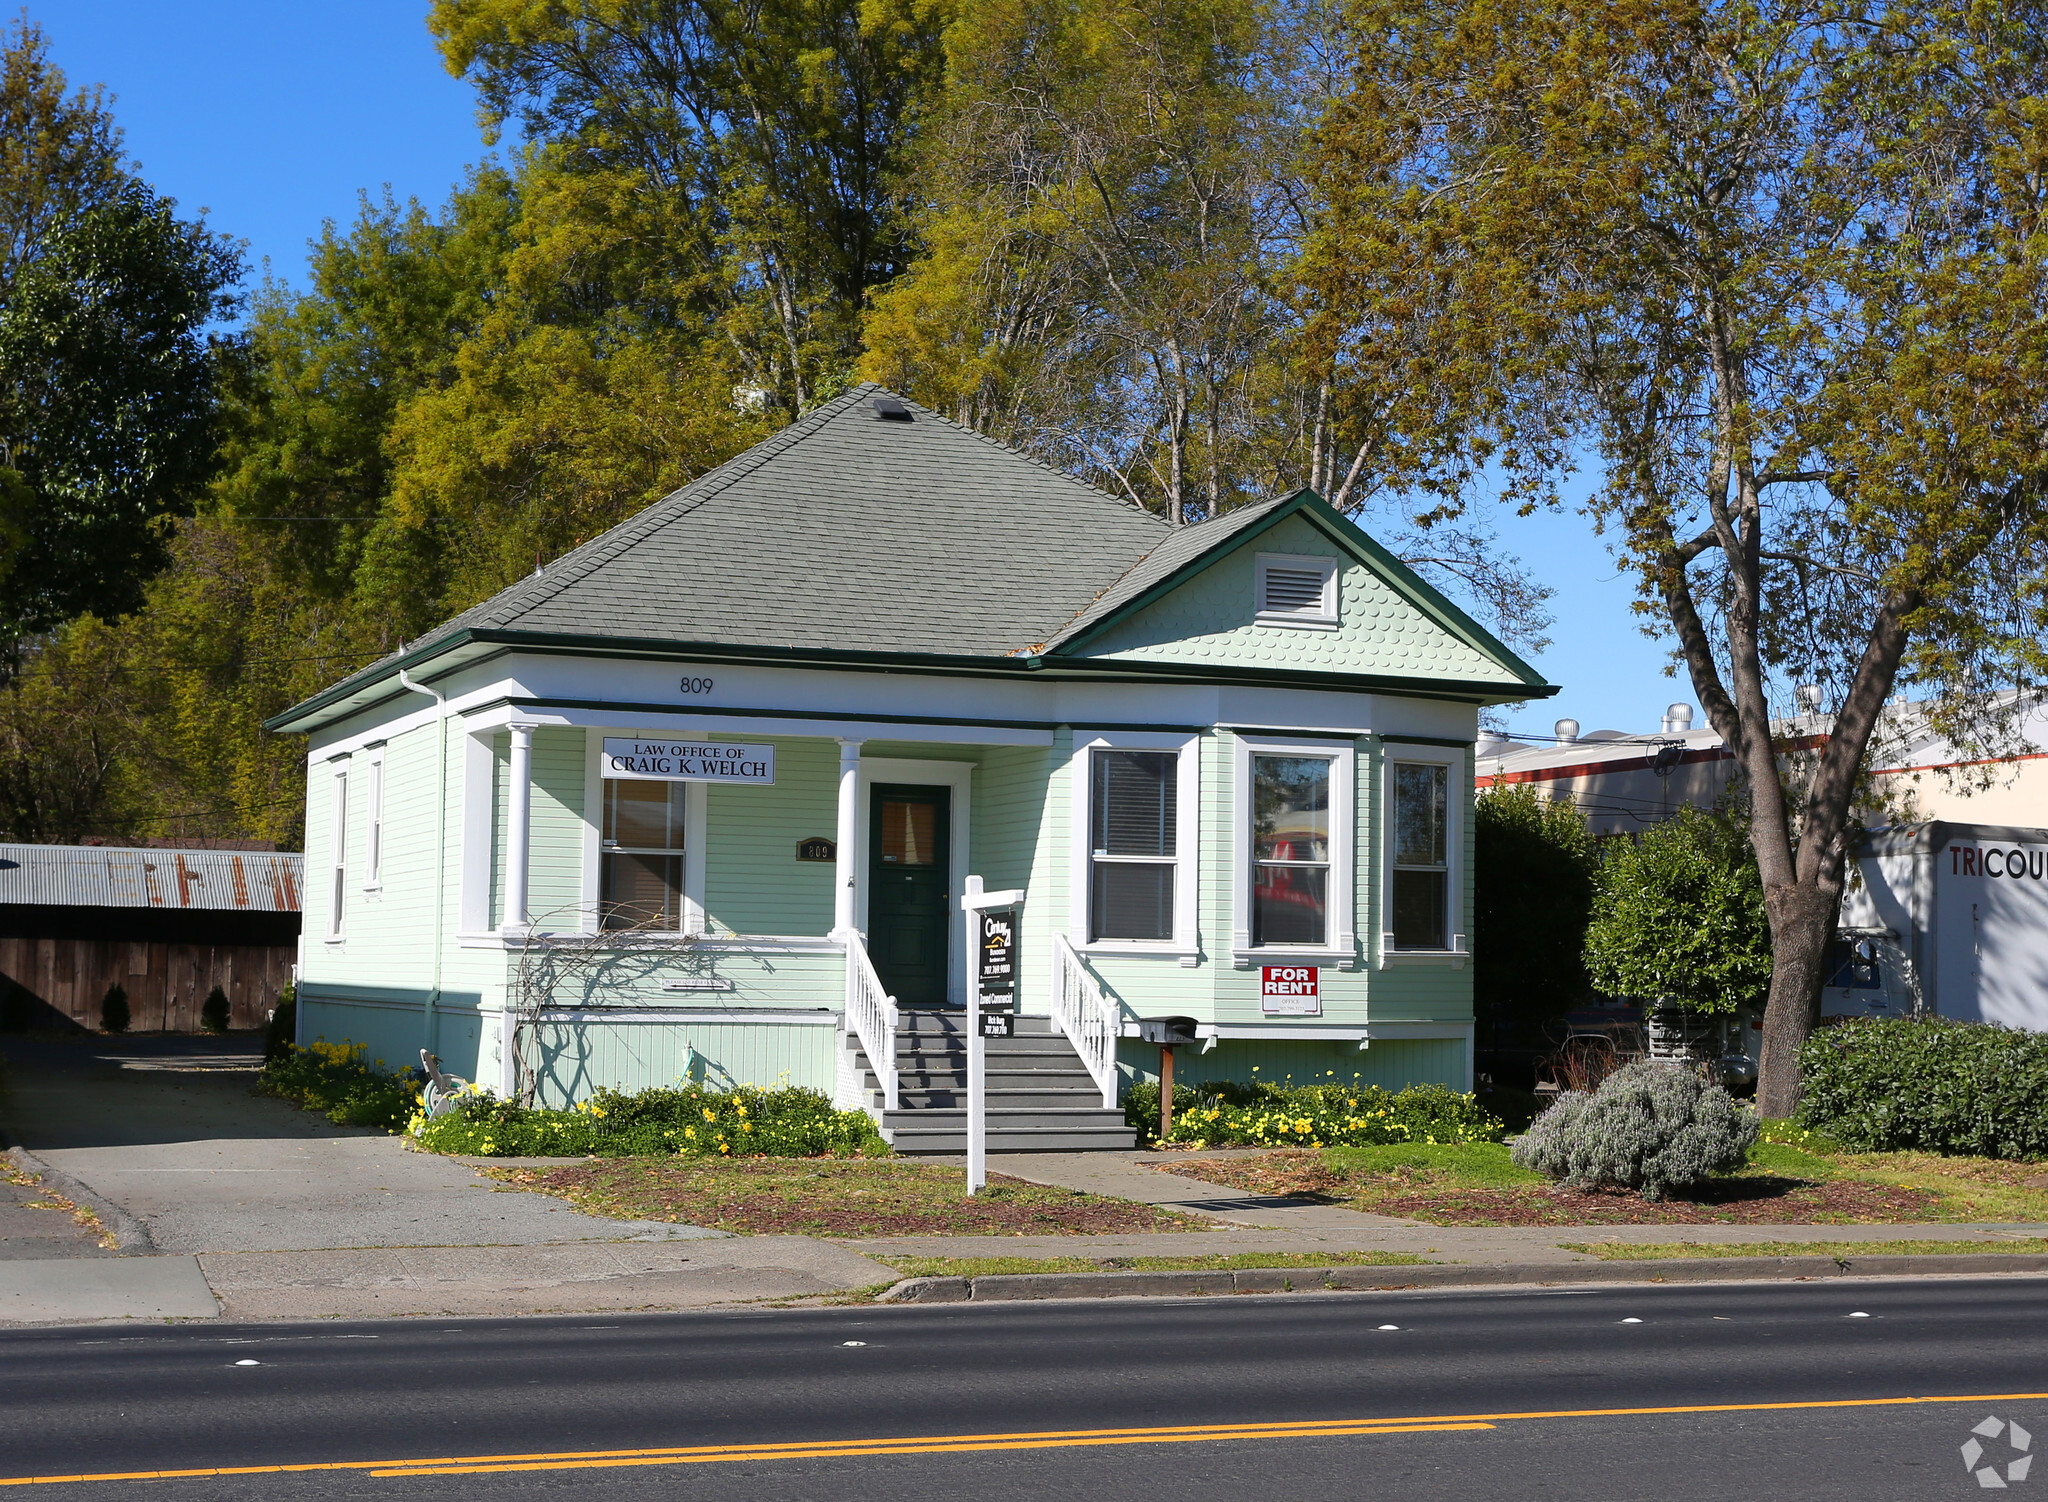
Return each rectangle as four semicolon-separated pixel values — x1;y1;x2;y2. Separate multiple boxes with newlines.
270;385;1552;1148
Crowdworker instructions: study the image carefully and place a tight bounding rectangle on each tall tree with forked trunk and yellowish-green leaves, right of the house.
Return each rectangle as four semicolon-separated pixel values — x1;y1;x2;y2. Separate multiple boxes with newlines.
1309;0;2048;1115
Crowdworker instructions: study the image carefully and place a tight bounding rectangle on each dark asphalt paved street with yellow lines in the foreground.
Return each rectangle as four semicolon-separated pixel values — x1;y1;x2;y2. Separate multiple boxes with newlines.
0;1279;2048;1502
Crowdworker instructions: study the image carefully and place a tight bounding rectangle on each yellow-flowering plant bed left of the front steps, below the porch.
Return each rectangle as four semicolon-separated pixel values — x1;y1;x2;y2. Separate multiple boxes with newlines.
410;1086;889;1158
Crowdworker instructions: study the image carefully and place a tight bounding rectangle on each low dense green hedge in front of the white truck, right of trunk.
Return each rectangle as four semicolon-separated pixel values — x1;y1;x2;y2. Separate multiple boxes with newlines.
1798;1016;2048;1158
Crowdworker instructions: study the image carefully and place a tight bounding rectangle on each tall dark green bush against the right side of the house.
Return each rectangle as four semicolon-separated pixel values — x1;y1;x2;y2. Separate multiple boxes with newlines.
1473;785;1597;1027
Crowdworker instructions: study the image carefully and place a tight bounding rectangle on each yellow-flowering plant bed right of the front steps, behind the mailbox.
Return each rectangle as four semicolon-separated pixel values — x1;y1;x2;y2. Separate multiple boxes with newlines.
1124;1076;1501;1148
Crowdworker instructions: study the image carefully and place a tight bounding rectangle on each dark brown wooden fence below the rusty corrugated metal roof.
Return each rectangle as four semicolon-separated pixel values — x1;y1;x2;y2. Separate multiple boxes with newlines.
0;936;297;1033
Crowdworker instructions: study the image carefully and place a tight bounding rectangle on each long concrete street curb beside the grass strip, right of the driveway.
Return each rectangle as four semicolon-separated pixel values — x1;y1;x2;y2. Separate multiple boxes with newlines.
877;1252;2048;1303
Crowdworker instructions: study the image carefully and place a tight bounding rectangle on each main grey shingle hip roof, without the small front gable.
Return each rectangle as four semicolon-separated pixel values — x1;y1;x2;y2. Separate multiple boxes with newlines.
391;385;1171;656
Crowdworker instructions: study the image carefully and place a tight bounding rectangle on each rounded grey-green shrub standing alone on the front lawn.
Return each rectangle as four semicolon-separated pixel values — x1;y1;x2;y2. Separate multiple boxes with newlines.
1513;1061;1759;1199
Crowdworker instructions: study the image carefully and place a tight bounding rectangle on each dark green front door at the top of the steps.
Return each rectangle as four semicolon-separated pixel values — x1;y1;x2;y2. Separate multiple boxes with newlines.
868;783;952;1006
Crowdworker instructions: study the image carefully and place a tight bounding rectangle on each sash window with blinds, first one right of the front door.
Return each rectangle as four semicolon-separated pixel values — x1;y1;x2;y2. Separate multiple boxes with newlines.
1087;748;1180;941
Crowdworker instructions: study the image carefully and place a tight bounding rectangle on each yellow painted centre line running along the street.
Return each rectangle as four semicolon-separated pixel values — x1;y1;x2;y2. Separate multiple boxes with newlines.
0;1393;2048;1486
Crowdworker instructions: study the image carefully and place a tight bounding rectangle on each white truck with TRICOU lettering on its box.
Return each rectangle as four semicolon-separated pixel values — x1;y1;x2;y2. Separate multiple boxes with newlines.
1821;822;2048;1031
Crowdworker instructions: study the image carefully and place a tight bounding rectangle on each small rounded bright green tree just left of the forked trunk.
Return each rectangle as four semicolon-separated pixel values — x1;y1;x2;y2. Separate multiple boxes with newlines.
1585;807;1772;1014
